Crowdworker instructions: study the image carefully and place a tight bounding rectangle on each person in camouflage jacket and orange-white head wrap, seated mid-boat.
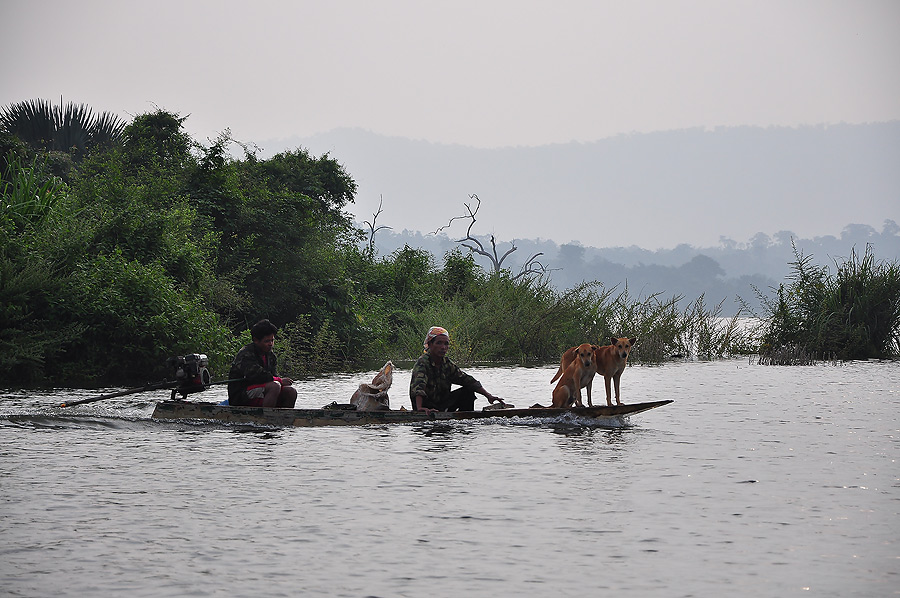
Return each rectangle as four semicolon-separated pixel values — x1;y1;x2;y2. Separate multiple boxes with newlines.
409;326;500;413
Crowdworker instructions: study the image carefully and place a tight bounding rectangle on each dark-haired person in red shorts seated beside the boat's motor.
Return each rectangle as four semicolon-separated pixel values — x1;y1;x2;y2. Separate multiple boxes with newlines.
228;320;297;408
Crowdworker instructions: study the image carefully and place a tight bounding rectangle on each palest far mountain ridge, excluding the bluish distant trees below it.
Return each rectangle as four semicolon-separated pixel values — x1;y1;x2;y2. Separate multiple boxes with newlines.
262;121;900;249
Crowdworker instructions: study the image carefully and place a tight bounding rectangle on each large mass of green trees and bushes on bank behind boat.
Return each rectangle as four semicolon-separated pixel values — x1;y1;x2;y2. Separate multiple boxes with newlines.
0;103;884;386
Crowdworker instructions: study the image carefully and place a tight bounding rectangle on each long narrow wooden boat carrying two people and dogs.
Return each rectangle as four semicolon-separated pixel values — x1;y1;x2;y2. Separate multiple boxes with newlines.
152;400;672;427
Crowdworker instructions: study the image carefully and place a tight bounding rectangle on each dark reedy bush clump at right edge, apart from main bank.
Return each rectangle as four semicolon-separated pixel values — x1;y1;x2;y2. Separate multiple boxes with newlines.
760;246;900;364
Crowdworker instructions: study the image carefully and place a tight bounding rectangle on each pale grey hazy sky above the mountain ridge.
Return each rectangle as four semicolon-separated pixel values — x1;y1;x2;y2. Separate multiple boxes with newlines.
0;0;900;248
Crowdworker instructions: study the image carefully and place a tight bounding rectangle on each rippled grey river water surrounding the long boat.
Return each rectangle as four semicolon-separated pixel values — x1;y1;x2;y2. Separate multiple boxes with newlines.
0;360;900;598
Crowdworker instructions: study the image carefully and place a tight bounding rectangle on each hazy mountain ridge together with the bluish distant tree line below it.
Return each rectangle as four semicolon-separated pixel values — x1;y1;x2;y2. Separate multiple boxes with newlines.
253;121;900;313
